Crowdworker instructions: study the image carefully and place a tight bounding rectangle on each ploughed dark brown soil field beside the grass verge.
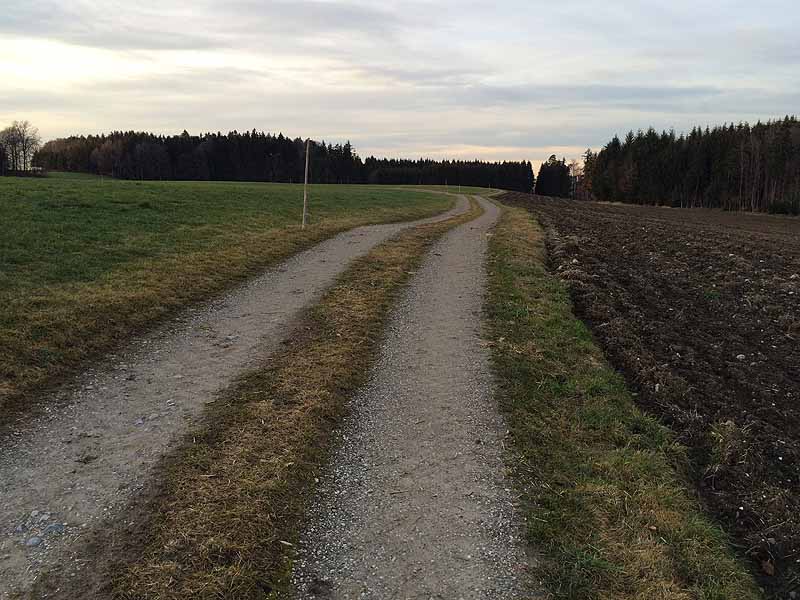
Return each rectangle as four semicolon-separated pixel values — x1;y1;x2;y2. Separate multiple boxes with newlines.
501;194;800;598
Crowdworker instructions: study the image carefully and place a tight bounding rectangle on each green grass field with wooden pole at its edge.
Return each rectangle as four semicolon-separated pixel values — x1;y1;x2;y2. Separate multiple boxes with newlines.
0;175;452;421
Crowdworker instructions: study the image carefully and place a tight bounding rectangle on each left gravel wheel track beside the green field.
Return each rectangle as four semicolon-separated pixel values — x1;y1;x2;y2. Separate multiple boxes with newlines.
0;198;468;598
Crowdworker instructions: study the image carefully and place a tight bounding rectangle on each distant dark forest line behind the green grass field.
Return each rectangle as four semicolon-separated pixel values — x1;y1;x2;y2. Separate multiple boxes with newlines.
35;130;534;192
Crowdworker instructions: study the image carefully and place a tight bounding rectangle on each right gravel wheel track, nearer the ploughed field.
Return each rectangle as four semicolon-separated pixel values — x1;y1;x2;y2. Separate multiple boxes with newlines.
293;196;533;600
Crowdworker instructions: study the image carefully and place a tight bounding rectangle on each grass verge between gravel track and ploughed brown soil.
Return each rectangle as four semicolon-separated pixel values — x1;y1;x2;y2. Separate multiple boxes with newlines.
487;208;761;600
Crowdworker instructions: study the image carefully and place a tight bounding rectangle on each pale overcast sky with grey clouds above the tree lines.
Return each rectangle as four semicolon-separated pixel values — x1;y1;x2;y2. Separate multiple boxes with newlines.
0;0;800;162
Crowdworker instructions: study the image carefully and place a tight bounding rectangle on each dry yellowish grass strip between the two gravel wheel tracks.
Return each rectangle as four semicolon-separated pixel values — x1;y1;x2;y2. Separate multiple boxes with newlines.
94;203;481;599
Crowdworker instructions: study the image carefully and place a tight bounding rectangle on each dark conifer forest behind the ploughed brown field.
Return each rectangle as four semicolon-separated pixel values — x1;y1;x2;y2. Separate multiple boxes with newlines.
577;116;800;214
